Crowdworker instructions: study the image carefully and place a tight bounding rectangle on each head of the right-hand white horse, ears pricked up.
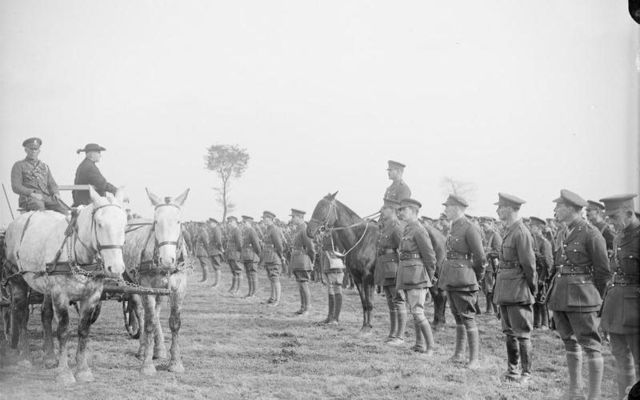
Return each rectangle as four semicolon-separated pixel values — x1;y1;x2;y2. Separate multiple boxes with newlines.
145;189;189;267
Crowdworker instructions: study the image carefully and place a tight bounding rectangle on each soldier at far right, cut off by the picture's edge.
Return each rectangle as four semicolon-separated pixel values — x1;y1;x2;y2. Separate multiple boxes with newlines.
600;194;640;398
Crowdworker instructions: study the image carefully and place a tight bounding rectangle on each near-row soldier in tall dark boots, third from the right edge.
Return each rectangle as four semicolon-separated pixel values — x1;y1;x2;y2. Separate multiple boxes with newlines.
495;193;538;384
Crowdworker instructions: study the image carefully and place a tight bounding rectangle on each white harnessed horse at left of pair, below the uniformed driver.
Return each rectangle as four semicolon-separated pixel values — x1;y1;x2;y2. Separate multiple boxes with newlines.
5;189;126;383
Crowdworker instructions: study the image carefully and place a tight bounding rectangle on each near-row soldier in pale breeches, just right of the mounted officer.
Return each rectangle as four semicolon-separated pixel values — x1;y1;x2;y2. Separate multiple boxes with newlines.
396;199;437;356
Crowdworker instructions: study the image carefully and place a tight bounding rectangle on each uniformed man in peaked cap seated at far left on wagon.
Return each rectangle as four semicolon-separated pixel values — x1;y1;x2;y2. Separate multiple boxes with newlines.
11;138;68;214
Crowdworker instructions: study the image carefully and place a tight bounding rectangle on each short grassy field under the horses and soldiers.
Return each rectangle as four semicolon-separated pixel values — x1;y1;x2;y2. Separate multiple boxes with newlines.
0;270;616;400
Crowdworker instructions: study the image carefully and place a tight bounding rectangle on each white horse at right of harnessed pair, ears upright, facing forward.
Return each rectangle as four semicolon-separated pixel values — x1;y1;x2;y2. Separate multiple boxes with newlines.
123;189;189;375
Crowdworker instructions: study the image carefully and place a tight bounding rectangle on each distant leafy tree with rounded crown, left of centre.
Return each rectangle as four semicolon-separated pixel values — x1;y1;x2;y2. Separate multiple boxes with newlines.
204;144;249;221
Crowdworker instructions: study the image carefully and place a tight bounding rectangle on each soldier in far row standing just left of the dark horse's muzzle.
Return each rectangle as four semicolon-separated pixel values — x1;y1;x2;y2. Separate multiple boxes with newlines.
290;208;316;316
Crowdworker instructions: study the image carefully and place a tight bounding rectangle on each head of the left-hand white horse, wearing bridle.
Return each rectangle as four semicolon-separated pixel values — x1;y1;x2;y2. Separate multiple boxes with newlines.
87;188;127;277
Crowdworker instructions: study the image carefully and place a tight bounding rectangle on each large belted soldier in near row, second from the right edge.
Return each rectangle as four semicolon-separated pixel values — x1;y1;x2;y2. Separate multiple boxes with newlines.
547;189;611;400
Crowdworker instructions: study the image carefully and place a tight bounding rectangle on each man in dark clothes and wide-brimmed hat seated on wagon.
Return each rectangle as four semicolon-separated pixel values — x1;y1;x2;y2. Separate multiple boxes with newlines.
72;143;118;207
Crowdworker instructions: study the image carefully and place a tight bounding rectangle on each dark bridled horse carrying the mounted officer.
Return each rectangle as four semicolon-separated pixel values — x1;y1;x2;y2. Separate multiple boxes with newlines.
307;192;378;333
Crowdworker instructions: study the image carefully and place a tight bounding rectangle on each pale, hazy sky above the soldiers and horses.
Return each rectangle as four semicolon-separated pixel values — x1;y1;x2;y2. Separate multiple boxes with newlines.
0;0;640;226
